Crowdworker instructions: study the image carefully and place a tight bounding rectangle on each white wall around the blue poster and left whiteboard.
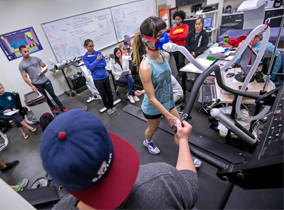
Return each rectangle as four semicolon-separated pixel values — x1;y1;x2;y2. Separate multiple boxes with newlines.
0;0;143;104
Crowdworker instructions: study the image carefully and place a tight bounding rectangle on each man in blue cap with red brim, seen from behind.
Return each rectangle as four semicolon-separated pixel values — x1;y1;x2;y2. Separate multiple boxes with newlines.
40;109;198;210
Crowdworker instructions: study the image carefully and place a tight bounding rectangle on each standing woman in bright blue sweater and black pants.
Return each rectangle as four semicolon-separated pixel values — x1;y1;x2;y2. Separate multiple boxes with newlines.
82;39;117;114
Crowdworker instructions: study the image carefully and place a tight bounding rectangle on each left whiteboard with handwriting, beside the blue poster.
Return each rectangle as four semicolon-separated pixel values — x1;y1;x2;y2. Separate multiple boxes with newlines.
42;8;117;62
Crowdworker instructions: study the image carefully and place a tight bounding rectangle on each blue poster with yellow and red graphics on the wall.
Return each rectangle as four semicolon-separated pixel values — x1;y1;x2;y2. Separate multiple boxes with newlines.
0;27;42;61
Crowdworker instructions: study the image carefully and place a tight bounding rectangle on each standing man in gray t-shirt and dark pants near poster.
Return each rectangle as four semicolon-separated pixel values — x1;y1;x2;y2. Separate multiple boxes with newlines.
19;45;67;113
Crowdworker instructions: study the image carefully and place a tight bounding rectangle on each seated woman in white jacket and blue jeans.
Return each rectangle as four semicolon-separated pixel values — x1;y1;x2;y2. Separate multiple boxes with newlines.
111;48;140;103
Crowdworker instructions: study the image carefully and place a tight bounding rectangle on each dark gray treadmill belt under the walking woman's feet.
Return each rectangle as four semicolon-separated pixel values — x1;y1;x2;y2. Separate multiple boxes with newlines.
106;110;231;209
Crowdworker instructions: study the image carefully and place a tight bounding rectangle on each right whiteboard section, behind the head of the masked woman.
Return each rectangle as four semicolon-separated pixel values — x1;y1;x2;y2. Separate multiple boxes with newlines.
111;0;155;42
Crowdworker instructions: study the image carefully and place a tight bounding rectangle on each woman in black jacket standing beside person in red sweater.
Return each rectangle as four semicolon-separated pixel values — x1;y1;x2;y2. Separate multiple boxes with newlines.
185;17;209;58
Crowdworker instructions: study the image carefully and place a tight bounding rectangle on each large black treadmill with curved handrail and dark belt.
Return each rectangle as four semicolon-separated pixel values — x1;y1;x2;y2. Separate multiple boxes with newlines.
106;65;284;209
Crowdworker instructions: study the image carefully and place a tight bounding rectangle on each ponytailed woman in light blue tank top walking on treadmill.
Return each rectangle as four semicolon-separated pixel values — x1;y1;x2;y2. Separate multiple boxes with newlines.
133;16;180;154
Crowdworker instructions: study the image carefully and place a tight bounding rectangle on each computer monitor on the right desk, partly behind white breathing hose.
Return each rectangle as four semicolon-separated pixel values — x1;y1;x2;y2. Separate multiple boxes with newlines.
235;46;257;82
